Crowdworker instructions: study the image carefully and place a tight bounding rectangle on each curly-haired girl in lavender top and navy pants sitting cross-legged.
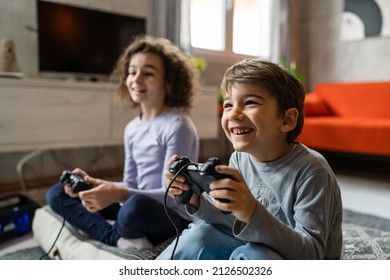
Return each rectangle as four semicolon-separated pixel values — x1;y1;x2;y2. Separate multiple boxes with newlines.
47;36;199;250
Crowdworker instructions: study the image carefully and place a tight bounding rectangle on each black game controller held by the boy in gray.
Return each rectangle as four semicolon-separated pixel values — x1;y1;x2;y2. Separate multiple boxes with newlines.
169;157;230;205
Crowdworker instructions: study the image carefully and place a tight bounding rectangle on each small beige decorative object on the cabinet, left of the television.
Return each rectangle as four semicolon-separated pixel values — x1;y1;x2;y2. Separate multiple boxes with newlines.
0;38;21;76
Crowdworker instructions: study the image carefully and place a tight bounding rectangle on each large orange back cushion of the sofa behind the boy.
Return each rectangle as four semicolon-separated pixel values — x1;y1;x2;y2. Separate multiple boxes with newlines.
314;82;390;118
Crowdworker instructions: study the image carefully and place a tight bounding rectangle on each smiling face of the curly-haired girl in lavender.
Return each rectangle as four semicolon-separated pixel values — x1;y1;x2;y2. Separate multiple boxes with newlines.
126;53;165;109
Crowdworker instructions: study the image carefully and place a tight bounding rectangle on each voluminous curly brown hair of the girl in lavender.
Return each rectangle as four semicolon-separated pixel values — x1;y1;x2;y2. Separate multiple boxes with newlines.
112;35;199;110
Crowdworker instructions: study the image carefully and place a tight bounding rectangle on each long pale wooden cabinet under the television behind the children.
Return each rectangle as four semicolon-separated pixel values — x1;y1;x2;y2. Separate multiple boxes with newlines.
0;79;219;152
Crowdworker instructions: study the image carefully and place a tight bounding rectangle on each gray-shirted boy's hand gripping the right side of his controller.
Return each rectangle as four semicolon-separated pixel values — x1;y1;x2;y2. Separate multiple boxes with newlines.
209;165;257;223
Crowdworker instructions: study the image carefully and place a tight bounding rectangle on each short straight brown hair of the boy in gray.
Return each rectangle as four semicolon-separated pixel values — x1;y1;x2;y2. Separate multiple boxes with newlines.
221;59;305;143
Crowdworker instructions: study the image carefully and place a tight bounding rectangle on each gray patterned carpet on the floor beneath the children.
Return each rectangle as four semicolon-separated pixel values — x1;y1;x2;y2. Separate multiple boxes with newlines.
0;210;390;260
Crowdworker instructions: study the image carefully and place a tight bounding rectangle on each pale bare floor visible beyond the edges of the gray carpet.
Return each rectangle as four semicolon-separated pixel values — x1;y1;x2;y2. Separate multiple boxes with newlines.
0;165;390;256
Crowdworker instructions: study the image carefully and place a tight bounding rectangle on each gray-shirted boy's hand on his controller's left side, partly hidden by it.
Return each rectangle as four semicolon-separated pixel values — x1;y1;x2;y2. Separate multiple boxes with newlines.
164;155;200;208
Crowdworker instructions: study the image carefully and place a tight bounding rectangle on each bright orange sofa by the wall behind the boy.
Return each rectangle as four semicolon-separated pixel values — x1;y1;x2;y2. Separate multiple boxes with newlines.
298;82;390;156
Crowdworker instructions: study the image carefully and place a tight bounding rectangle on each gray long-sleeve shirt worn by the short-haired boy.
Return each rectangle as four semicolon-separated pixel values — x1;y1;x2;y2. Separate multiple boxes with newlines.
187;144;342;259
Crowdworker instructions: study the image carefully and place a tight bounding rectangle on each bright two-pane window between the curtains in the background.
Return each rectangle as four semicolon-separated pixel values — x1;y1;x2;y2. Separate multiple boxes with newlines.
189;0;272;59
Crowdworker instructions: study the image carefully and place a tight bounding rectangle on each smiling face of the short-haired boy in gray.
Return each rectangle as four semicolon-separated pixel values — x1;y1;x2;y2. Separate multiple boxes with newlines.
221;85;290;162
